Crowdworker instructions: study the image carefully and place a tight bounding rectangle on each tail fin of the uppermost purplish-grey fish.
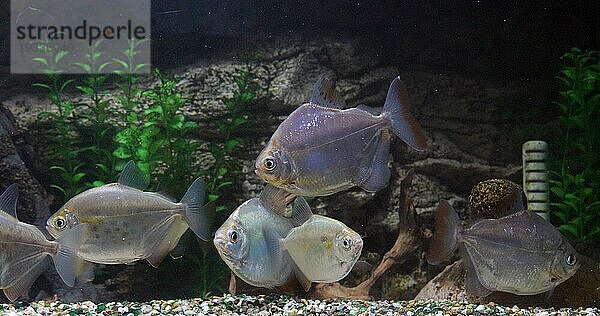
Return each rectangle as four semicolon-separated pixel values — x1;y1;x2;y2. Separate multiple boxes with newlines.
383;77;427;150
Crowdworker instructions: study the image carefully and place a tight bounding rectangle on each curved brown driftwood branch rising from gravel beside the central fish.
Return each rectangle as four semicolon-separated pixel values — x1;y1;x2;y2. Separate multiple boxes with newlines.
308;169;422;300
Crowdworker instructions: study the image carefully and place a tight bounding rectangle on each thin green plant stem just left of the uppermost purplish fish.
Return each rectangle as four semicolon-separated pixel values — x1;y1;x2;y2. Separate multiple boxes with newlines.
207;62;259;211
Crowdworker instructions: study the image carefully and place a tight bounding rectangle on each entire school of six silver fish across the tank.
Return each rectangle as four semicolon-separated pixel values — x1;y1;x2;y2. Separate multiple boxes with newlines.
0;76;579;301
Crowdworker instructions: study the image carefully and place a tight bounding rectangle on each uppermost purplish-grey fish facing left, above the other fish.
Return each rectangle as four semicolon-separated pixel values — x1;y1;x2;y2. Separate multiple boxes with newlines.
255;77;427;196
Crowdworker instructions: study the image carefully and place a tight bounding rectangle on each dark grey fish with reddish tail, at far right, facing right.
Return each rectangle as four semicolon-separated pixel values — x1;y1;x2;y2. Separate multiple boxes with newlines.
428;201;580;296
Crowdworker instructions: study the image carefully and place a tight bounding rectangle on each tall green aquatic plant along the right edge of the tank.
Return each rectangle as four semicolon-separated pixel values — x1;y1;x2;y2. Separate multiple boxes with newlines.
550;48;600;243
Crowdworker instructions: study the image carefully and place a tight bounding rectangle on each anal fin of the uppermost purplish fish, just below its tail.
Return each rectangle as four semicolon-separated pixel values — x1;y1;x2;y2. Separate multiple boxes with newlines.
357;130;391;192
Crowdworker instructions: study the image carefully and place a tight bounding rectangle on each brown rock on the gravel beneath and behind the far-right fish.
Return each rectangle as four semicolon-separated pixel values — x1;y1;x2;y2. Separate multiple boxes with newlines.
415;255;600;307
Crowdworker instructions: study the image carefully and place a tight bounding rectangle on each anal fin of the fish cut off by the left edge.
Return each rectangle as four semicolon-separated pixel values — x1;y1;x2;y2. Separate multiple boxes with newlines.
1;253;48;302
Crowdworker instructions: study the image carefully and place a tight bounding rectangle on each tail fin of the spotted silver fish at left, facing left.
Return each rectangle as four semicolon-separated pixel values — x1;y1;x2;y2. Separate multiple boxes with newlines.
181;178;209;241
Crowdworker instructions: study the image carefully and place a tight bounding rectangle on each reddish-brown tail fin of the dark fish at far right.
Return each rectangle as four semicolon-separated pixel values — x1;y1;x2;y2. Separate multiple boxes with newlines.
427;200;460;265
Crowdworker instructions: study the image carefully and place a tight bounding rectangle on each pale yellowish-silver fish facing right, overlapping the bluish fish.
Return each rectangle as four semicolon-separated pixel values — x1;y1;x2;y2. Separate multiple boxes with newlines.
281;214;363;283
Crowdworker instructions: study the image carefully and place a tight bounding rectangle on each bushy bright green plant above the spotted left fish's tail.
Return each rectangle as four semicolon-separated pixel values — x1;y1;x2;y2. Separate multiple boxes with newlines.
113;69;197;195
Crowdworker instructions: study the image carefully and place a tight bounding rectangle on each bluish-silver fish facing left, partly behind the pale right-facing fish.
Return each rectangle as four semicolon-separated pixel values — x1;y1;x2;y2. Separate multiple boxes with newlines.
213;186;311;288
